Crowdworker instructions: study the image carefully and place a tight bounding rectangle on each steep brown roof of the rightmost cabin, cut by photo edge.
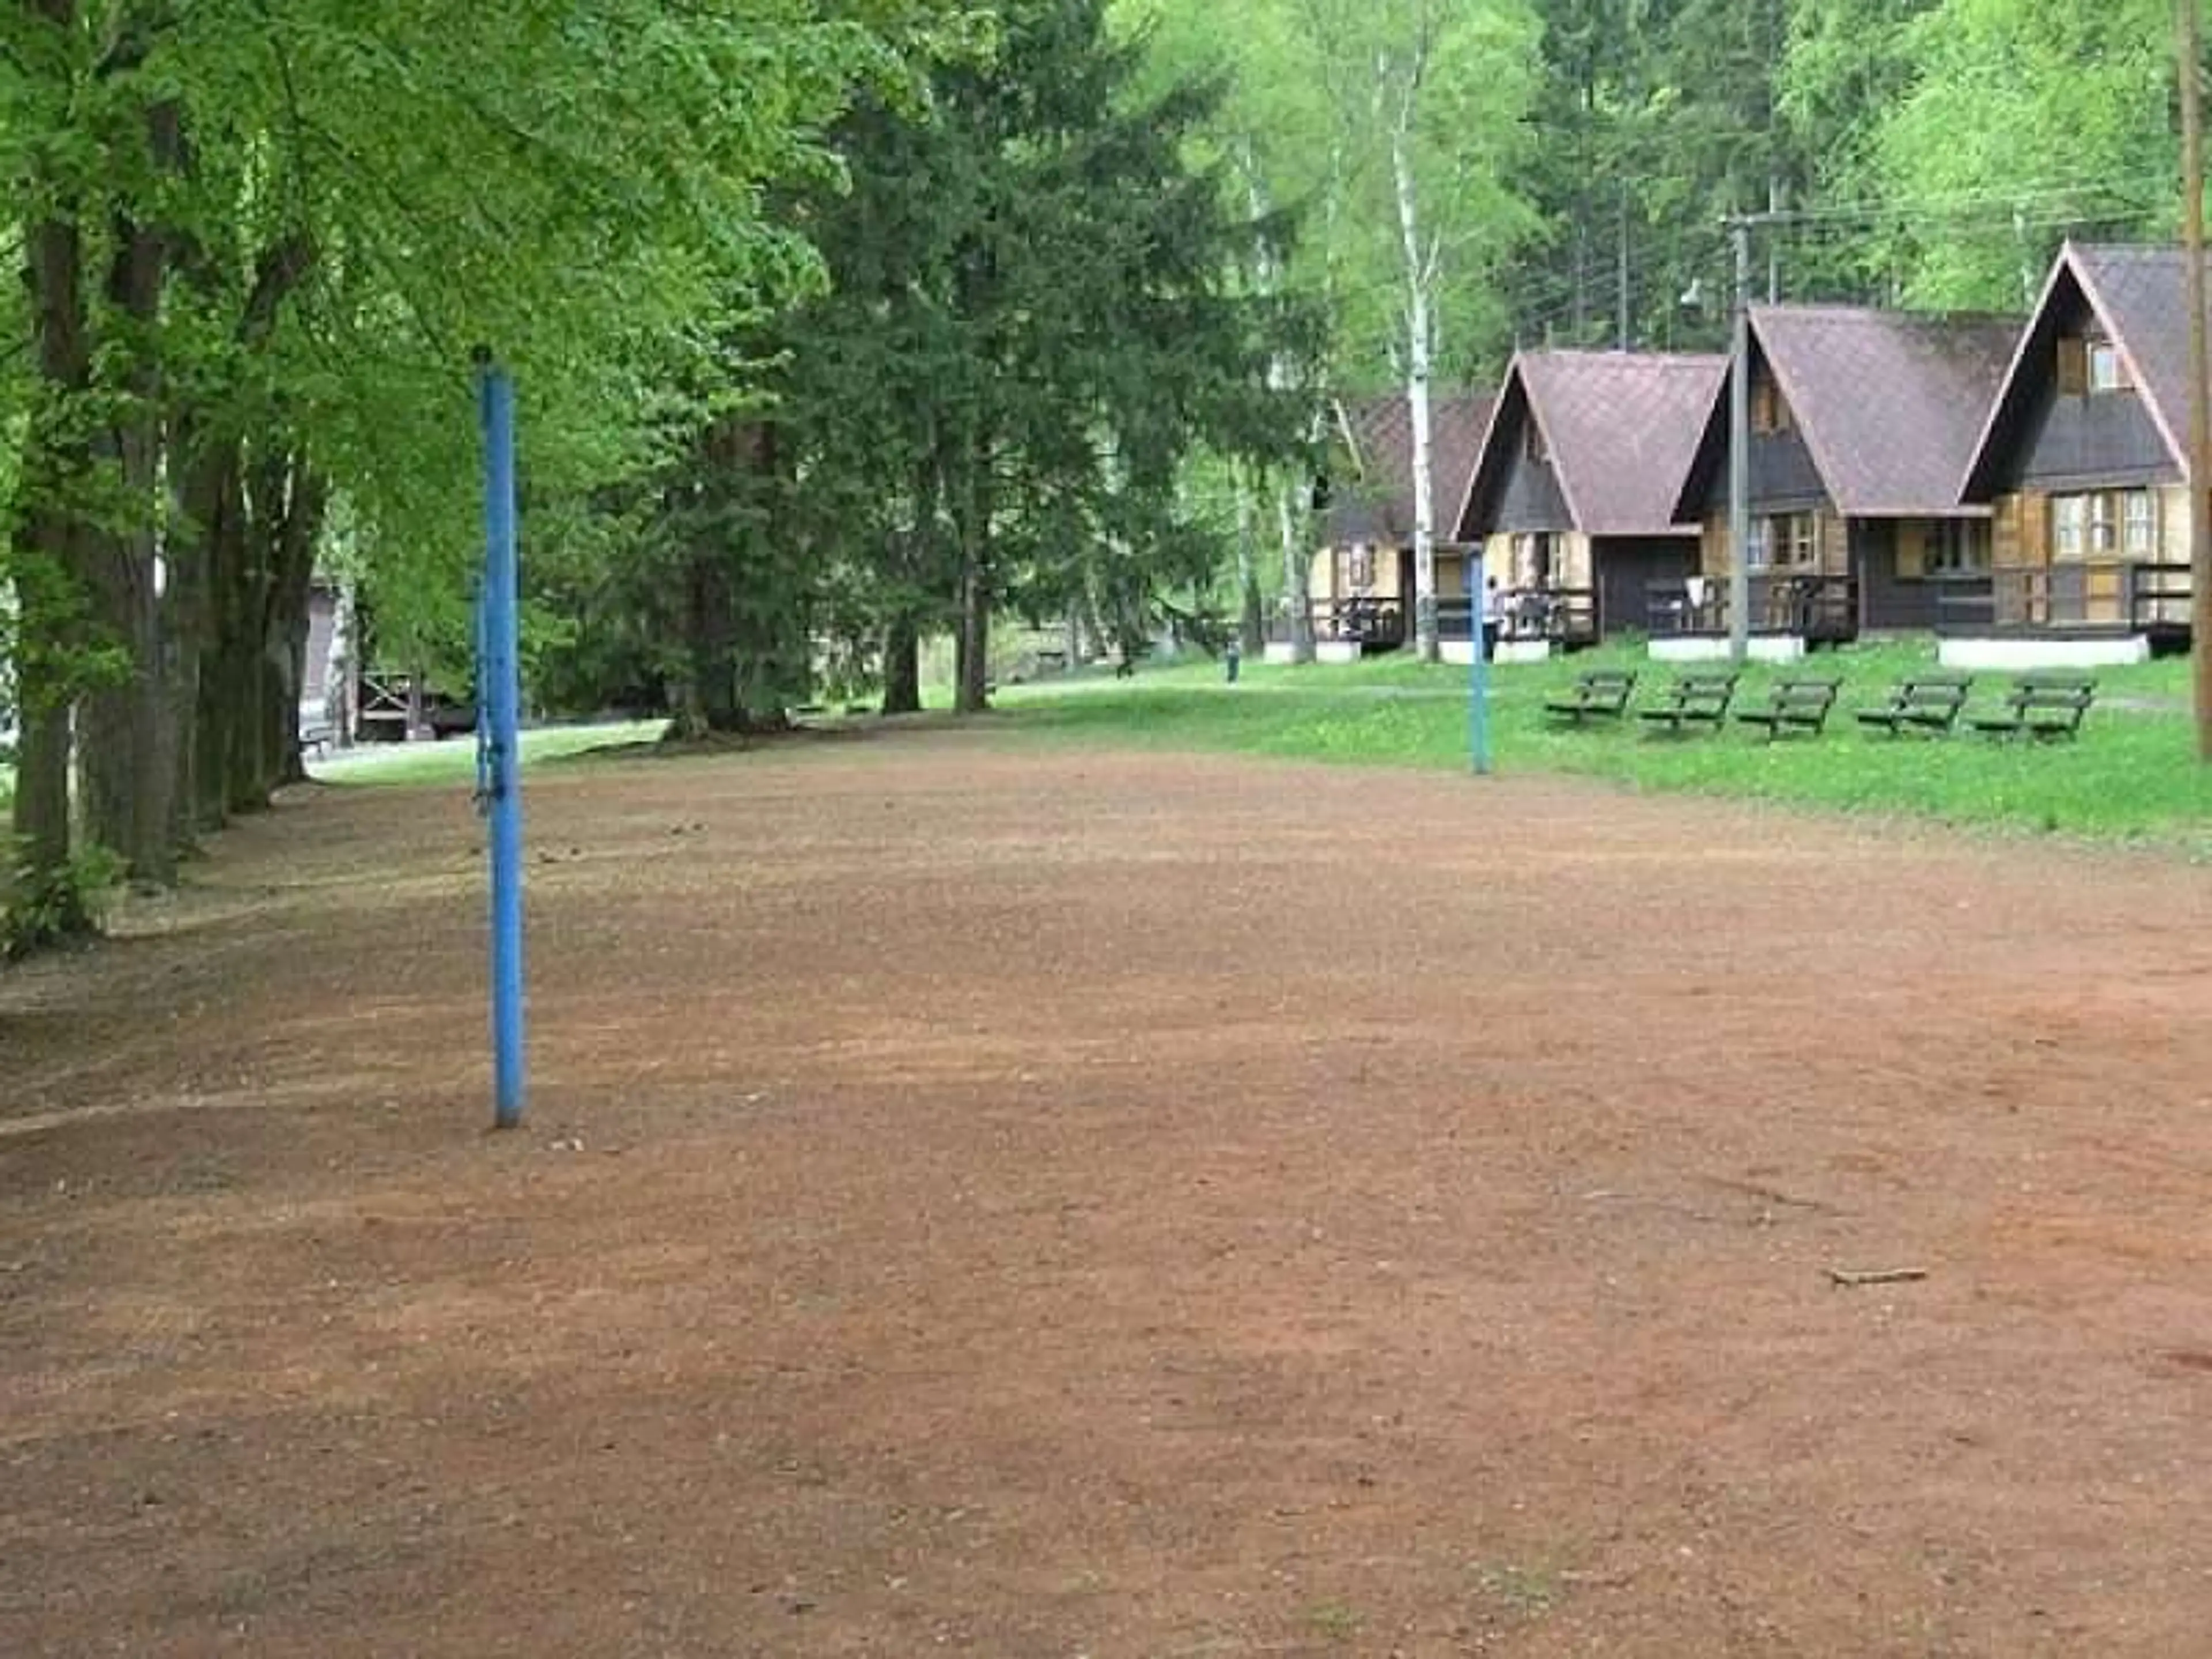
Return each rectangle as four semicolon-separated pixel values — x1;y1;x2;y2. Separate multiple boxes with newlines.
1962;241;2190;495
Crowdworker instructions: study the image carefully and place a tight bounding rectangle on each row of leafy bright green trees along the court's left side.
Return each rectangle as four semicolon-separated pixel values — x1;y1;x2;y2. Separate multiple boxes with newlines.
0;0;951;945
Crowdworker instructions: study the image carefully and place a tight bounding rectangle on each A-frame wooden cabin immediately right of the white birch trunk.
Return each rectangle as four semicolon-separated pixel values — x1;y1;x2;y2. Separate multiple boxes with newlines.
1458;352;1728;646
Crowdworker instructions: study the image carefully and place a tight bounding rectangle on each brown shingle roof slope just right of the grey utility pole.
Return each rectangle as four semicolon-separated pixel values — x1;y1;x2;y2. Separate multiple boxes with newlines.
1752;305;2020;518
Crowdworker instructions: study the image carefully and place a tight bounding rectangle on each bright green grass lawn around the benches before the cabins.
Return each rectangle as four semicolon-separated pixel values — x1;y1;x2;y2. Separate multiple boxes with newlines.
1000;643;2212;854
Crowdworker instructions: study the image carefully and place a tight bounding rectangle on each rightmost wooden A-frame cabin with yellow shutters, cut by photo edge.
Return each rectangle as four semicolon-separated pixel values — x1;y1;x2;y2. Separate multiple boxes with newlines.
1944;243;2190;666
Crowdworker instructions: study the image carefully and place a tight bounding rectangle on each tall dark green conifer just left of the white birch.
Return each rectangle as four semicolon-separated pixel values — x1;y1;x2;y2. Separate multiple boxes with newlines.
646;0;1307;725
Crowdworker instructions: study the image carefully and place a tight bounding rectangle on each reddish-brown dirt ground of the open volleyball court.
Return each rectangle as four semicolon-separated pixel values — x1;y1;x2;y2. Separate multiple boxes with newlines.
0;730;2212;1659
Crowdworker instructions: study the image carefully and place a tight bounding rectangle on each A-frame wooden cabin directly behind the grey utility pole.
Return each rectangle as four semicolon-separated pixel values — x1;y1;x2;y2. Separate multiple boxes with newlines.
1654;305;2020;648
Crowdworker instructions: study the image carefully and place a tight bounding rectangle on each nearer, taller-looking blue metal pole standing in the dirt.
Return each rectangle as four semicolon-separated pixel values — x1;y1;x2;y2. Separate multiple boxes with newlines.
476;358;524;1128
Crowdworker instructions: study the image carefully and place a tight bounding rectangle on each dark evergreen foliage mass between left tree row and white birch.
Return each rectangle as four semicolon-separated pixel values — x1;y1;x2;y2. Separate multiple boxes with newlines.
569;0;1309;724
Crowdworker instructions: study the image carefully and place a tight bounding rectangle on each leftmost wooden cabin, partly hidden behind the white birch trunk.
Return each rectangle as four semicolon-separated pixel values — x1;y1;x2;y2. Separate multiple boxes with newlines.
1309;392;1491;659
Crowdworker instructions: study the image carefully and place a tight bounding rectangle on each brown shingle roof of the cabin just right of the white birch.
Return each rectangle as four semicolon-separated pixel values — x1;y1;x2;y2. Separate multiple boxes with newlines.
1460;352;1728;535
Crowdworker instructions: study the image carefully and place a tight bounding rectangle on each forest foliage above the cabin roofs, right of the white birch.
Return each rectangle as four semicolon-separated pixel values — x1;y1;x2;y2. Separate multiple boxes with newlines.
1498;0;2175;350
